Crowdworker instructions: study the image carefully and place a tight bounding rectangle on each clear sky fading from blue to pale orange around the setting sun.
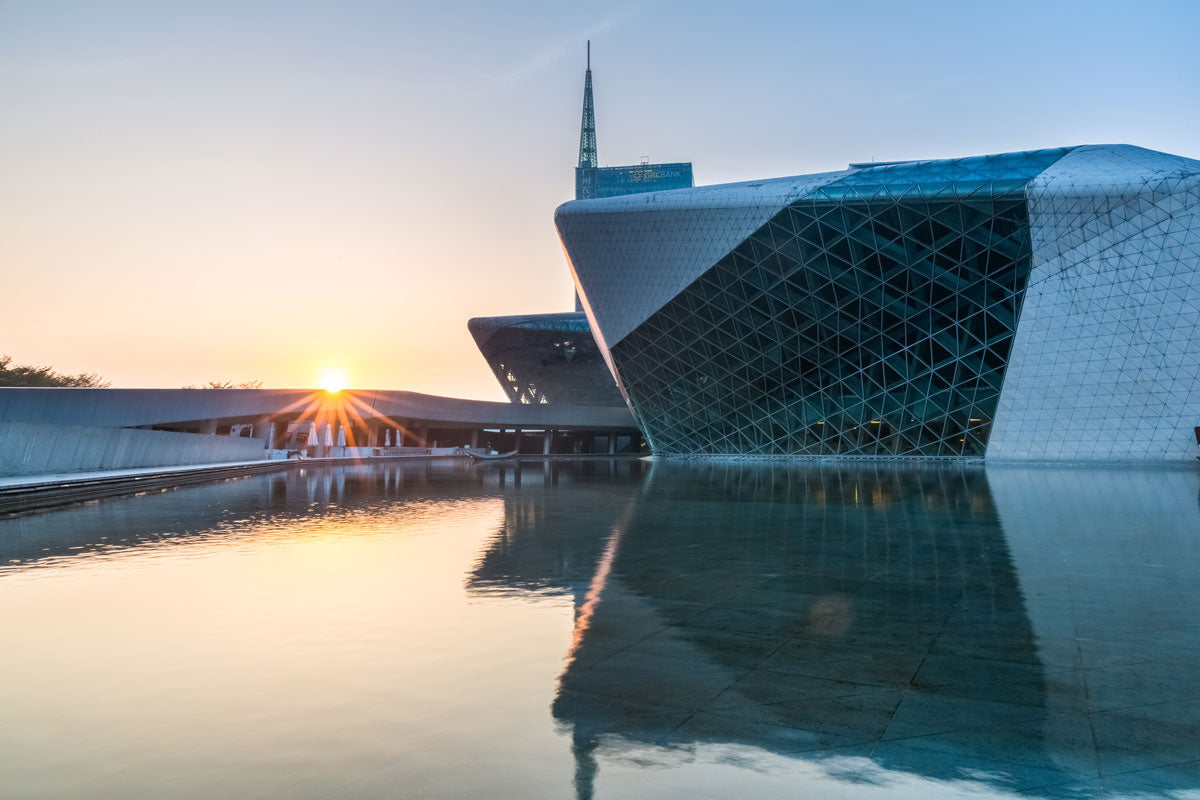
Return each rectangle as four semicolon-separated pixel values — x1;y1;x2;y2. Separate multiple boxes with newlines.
0;0;1200;399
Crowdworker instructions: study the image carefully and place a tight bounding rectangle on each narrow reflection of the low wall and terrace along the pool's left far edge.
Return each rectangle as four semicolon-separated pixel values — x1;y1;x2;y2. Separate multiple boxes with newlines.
0;459;644;575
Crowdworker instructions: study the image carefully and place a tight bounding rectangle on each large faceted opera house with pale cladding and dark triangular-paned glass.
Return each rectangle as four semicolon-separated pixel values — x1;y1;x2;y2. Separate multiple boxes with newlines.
559;145;1200;462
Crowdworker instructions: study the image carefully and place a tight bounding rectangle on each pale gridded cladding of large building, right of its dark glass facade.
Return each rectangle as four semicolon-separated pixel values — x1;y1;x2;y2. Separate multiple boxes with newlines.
986;145;1200;462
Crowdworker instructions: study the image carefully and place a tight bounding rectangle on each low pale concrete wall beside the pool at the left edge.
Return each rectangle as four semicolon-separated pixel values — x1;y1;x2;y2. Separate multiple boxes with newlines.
0;420;265;477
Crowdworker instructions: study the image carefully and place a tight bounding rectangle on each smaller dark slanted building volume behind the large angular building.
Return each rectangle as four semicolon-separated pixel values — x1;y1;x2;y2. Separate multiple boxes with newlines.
467;312;625;405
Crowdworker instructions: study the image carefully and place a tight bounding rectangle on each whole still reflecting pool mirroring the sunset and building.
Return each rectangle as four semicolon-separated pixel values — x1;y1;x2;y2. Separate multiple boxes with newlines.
0;459;1200;800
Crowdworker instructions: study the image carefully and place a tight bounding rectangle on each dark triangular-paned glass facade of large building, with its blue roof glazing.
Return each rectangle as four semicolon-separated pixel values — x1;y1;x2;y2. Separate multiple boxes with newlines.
612;149;1069;456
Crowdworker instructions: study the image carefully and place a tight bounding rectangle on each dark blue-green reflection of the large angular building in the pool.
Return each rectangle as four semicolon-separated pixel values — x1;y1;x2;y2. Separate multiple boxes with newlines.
473;462;1200;798
